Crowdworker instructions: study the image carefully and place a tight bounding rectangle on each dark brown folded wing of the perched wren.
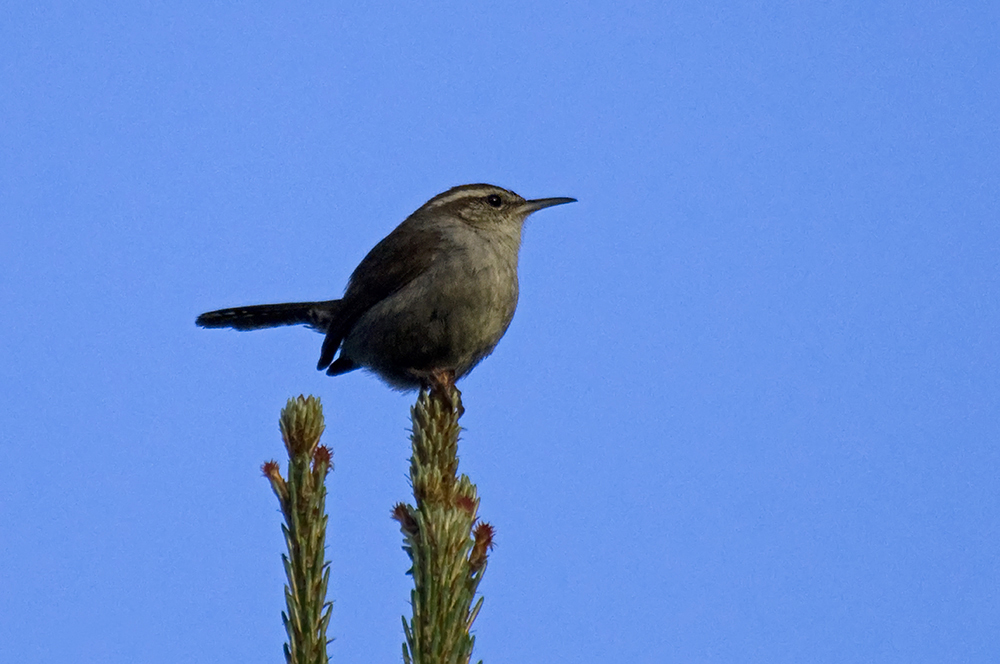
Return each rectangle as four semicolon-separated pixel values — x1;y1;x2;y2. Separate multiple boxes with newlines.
316;217;442;369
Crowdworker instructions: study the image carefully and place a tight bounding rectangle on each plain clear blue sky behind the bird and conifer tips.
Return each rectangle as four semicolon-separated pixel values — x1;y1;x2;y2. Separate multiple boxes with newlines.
0;2;1000;663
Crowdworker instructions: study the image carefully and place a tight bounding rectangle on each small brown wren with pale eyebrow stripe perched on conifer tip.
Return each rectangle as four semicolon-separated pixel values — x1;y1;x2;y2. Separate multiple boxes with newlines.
196;184;576;389
